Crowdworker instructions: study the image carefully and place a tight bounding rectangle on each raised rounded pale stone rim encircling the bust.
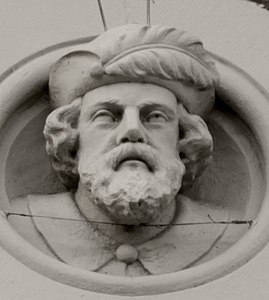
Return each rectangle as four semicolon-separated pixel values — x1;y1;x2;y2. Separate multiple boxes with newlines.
0;40;269;295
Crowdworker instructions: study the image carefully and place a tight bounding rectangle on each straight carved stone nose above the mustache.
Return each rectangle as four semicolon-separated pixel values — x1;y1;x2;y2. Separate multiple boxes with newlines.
117;107;146;145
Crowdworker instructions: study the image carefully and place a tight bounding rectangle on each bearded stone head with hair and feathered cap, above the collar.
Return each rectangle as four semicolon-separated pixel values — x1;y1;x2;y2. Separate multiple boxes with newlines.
44;25;218;225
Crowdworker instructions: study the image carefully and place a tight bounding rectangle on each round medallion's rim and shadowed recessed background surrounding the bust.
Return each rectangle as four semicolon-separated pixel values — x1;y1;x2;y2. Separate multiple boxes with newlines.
0;40;269;295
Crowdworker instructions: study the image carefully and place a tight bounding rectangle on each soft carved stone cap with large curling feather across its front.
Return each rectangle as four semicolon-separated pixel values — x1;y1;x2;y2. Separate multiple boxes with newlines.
49;24;219;115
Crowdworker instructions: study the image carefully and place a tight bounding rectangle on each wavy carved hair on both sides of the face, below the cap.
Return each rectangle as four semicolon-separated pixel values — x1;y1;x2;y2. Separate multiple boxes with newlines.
44;98;213;191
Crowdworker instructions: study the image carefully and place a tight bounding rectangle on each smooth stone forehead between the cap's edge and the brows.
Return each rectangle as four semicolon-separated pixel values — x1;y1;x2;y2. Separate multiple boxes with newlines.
82;82;177;109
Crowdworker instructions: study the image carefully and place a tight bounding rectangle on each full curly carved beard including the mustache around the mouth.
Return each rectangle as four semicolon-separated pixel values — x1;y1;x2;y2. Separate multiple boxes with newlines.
78;143;185;225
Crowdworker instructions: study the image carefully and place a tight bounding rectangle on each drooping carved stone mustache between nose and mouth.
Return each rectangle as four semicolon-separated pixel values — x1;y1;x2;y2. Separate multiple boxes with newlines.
103;143;160;172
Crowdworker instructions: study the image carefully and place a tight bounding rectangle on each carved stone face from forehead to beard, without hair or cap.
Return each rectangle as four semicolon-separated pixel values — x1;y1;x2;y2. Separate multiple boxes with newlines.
75;83;185;224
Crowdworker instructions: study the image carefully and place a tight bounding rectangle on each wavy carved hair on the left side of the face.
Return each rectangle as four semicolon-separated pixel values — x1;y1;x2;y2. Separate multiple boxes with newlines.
43;98;81;189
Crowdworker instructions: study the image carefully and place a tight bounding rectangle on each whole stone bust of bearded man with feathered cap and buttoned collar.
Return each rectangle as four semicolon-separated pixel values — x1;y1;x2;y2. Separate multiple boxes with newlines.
9;24;245;276
